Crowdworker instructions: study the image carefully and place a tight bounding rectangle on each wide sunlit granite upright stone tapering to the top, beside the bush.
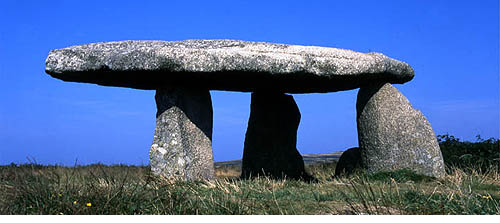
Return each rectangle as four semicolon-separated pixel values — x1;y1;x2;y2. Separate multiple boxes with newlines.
356;83;445;178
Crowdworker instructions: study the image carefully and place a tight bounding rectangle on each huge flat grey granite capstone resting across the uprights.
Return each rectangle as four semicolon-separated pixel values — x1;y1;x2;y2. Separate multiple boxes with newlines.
45;40;414;93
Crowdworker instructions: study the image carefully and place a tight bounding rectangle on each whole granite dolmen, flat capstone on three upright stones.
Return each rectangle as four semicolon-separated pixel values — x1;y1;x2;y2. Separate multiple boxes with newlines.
45;40;445;180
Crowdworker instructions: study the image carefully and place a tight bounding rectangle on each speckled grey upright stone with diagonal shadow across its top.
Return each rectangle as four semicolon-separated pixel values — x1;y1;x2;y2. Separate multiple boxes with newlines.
149;88;215;180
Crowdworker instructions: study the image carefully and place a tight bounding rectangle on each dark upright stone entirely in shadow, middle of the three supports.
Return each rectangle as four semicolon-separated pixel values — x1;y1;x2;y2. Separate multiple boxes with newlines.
241;92;309;179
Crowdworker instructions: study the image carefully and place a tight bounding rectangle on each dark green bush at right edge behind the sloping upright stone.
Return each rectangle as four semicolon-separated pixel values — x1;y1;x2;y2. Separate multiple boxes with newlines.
437;134;500;172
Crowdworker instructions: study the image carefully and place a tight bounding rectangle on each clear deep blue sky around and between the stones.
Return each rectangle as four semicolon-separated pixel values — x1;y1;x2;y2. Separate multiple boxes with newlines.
0;0;500;165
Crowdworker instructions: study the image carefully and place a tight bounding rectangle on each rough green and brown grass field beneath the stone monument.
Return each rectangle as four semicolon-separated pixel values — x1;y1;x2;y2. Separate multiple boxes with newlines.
0;163;500;215
